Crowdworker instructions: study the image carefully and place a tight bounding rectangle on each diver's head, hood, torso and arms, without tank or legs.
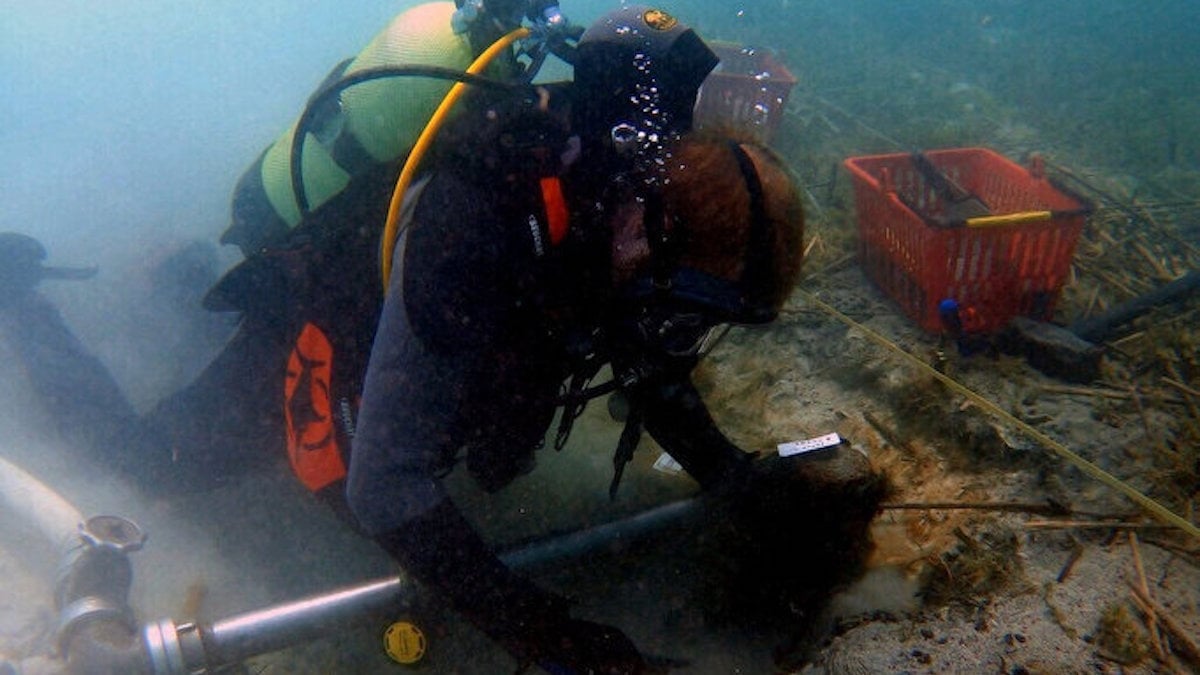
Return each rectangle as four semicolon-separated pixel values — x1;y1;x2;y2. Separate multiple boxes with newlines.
347;6;803;673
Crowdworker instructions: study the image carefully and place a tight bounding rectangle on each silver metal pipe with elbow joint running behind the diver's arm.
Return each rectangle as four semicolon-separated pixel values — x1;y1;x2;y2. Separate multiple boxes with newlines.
0;444;703;675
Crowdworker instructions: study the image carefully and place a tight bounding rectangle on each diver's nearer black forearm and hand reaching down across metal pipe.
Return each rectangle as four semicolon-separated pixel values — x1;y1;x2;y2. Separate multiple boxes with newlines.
376;500;644;675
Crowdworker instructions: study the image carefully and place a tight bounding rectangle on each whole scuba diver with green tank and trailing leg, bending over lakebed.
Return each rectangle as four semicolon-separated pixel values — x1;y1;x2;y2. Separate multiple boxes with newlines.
0;0;803;674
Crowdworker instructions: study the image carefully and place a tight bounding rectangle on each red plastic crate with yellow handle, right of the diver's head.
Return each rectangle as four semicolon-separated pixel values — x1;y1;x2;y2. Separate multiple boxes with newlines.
844;148;1091;333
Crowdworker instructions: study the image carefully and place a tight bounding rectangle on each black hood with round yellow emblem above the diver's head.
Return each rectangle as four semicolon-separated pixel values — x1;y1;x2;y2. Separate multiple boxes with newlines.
574;5;719;143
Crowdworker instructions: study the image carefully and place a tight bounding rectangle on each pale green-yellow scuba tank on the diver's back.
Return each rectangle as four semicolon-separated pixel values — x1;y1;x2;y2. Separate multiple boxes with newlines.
221;2;472;256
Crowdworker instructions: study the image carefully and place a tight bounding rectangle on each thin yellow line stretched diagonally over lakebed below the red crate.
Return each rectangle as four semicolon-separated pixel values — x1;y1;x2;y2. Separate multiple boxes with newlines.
797;289;1200;539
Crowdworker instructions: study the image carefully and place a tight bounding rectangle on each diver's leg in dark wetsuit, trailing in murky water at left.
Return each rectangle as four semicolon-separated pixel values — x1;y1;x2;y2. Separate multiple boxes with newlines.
0;292;286;494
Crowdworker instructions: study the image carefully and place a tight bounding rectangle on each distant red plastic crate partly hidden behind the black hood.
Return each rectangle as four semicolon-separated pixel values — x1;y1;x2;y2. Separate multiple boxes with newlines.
695;42;796;143
